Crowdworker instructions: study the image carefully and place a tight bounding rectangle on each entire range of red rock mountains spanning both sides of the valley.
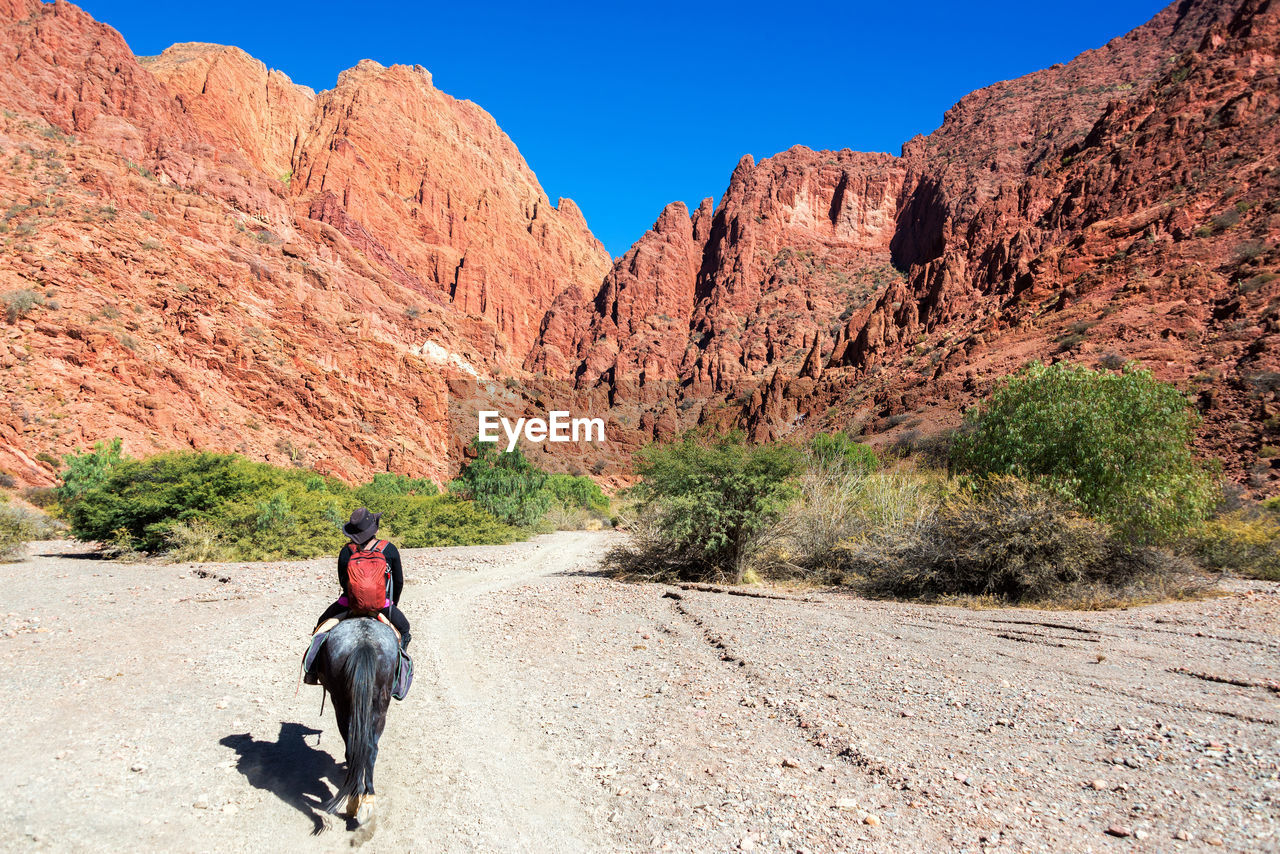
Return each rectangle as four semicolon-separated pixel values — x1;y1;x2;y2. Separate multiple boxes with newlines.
0;0;1280;492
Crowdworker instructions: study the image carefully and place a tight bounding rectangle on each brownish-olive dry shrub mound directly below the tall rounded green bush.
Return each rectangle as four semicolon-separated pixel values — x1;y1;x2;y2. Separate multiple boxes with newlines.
846;476;1181;603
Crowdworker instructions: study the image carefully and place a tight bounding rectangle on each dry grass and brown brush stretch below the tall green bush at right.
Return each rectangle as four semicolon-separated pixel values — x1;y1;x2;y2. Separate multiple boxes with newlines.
759;465;1211;609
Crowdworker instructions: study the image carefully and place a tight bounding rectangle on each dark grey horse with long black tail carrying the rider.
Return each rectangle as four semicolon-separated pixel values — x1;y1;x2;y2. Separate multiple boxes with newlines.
317;617;399;825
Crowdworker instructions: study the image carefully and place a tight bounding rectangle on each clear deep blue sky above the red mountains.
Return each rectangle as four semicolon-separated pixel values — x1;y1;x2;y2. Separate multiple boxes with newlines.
72;0;1165;256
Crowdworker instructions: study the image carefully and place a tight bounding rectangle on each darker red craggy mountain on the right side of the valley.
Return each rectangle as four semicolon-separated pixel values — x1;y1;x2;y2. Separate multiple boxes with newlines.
526;0;1280;492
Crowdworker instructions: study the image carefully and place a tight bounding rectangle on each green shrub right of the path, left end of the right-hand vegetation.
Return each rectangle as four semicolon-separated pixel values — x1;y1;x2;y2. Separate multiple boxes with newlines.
605;434;803;583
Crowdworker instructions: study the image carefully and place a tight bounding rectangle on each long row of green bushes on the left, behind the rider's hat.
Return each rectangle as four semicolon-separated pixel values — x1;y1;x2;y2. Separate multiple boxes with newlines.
59;442;518;561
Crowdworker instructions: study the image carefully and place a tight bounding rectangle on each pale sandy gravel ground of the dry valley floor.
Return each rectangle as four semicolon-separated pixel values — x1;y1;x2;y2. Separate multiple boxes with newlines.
0;533;1280;851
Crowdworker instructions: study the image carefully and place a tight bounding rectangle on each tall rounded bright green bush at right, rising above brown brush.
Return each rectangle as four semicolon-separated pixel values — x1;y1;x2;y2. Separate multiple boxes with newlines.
951;362;1217;542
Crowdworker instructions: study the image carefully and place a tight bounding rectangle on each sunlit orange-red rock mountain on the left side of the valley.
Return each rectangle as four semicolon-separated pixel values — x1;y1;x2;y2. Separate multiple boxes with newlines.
0;0;609;483
